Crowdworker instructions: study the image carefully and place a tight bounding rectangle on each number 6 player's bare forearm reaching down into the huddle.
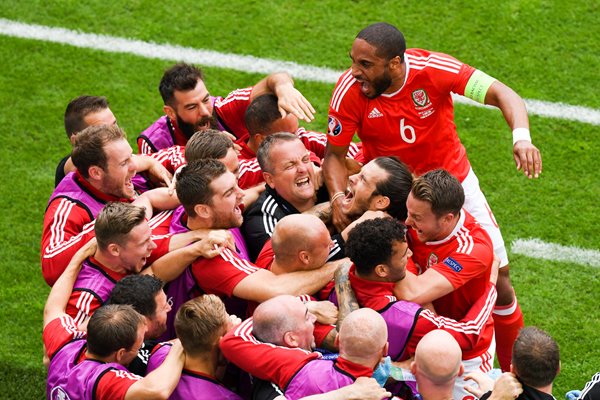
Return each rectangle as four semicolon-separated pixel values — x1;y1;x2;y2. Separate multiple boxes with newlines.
322;142;350;232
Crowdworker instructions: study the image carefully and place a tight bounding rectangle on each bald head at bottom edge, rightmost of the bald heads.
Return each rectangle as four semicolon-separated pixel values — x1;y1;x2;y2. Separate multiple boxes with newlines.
410;330;464;400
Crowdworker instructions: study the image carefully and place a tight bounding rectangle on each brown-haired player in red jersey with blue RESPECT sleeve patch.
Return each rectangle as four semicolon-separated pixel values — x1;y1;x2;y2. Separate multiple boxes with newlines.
395;170;494;319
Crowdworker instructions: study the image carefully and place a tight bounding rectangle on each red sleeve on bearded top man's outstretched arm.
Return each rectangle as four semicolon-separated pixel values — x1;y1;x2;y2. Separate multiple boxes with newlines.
214;87;253;142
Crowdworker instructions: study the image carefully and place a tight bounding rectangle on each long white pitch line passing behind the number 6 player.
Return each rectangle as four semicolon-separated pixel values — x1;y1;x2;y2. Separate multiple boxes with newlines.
0;18;600;125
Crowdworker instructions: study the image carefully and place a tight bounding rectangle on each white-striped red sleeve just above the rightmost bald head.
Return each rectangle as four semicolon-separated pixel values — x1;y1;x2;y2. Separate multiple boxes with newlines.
407;282;497;356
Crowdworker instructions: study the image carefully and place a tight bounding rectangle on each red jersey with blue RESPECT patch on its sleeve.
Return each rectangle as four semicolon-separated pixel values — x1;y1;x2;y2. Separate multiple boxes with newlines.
406;210;494;320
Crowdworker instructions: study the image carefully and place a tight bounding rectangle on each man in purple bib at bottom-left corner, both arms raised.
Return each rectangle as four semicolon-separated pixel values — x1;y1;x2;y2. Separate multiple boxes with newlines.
43;239;184;400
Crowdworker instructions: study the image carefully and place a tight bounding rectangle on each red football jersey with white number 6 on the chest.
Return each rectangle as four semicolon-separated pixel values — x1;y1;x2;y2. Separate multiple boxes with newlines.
327;49;475;181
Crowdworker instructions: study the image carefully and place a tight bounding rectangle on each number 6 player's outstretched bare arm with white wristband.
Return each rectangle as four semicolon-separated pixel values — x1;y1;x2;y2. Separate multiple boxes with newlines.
485;81;542;179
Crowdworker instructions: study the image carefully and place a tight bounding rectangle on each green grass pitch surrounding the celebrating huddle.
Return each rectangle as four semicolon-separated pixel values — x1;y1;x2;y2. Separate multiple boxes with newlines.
0;0;600;399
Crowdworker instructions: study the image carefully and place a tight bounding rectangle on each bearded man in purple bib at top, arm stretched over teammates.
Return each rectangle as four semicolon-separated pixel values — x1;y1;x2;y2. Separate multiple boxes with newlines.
137;63;315;154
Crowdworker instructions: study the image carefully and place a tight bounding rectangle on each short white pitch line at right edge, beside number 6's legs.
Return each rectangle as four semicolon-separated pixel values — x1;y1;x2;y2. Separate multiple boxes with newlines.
511;239;600;267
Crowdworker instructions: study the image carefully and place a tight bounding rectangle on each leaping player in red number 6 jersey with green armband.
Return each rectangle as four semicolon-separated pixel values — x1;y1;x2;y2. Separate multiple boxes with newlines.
323;22;542;370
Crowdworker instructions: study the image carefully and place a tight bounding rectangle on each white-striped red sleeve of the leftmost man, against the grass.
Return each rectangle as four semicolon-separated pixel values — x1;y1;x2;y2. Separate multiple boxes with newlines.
41;197;95;286
